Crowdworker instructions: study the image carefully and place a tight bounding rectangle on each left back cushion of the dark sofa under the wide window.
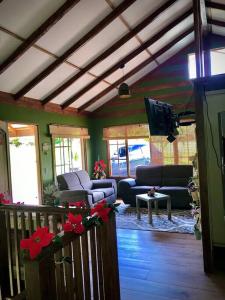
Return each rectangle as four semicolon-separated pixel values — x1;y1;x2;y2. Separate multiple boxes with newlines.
136;166;162;186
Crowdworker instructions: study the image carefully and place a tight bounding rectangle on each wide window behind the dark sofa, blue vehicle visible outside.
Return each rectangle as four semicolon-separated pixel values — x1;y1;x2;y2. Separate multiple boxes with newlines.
103;124;196;177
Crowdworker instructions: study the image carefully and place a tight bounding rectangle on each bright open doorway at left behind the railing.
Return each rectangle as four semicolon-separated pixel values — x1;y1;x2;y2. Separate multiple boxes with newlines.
8;123;41;205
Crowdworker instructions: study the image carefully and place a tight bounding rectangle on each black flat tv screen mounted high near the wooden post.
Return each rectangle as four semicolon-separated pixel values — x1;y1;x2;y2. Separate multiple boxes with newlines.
144;98;178;136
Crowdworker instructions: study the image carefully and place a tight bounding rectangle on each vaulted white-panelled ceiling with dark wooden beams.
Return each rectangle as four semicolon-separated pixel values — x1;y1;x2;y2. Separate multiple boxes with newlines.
0;0;225;112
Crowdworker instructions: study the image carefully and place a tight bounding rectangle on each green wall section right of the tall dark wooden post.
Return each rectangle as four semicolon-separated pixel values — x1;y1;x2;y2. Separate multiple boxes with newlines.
204;91;225;246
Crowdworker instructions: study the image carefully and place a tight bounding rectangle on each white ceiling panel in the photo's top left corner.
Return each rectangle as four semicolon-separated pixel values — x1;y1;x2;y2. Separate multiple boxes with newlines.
0;0;65;38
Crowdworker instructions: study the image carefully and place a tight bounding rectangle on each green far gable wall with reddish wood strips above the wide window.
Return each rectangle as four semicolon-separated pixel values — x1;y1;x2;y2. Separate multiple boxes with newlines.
91;48;193;170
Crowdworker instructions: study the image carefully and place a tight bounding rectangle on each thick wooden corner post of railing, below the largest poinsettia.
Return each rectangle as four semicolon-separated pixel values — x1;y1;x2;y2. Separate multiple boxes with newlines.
24;255;57;300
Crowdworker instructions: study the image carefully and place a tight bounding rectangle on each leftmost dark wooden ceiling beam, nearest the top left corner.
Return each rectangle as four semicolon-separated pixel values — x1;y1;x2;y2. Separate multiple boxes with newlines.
0;0;80;74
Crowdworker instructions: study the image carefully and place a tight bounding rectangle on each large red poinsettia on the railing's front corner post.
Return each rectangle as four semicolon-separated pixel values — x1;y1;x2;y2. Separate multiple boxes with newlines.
20;227;54;259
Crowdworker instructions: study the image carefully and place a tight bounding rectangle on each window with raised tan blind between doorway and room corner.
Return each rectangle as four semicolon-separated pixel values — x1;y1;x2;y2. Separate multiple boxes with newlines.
50;125;89;176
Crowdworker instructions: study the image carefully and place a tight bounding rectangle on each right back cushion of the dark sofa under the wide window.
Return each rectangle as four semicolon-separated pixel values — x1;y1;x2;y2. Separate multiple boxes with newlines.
162;165;193;187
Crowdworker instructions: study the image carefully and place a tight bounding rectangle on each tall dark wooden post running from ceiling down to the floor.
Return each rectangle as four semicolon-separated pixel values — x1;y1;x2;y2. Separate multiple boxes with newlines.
193;0;213;273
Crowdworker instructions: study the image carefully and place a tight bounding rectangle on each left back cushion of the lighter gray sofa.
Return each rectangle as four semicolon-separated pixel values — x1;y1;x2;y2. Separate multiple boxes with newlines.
57;172;83;191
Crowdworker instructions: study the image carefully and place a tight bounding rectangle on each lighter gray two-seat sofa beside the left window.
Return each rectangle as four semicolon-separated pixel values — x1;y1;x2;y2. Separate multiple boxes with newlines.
57;170;117;206
